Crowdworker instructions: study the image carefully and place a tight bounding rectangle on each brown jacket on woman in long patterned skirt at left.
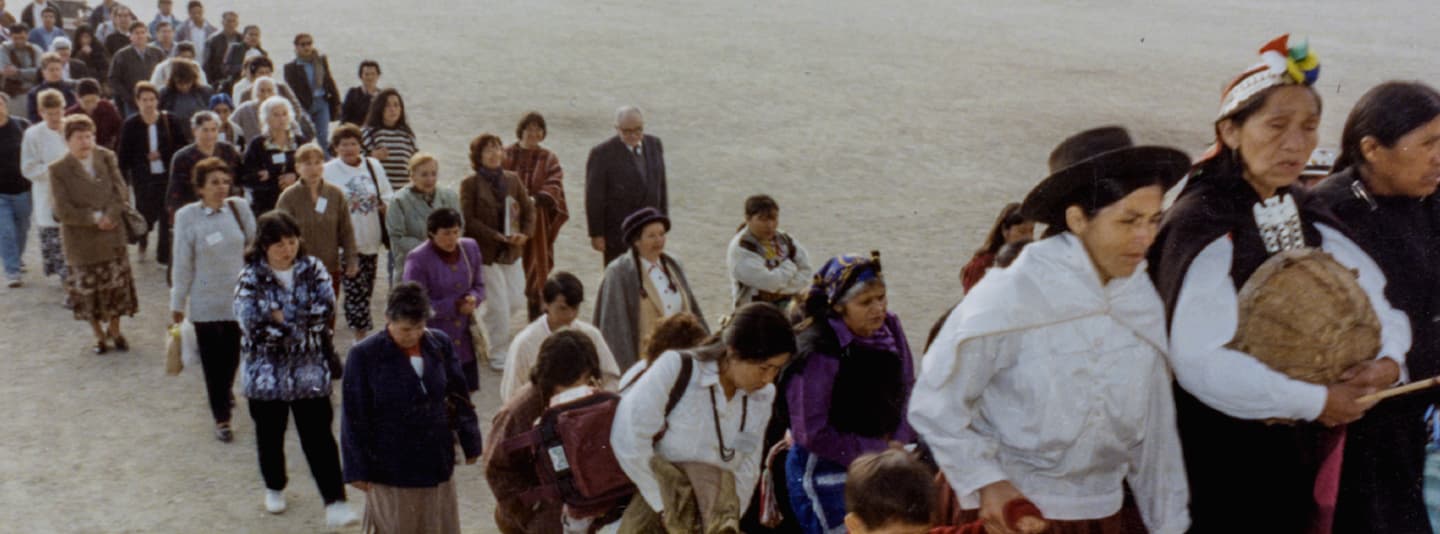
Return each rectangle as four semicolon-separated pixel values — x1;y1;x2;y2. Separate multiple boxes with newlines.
49;147;130;266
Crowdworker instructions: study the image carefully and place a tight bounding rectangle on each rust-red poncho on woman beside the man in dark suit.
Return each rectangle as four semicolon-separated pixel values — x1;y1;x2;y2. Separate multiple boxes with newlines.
504;142;570;308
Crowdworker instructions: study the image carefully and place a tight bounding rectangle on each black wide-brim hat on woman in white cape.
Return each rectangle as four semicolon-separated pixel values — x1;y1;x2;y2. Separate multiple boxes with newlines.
1020;127;1191;226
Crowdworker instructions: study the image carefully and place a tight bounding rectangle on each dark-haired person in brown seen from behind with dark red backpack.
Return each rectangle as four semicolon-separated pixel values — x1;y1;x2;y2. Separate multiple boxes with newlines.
484;330;603;534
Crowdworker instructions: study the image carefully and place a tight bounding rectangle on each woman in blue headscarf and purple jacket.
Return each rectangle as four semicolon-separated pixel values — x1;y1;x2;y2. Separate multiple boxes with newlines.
785;253;914;533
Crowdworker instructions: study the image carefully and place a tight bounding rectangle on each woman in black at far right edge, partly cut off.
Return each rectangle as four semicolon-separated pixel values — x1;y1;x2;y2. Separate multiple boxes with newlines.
1313;82;1440;533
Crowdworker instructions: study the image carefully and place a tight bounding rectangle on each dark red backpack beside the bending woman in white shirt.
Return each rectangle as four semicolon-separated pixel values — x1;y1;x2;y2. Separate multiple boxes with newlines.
500;357;693;517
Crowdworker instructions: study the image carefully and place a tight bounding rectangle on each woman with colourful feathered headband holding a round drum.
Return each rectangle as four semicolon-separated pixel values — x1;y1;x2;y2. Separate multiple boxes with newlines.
1149;36;1410;533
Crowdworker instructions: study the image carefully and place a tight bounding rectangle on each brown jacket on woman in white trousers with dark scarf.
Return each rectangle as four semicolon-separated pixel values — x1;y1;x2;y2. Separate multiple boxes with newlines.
459;171;536;265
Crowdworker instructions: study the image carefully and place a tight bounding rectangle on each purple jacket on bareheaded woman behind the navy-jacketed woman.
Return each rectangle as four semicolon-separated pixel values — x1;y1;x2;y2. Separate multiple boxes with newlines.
403;237;485;363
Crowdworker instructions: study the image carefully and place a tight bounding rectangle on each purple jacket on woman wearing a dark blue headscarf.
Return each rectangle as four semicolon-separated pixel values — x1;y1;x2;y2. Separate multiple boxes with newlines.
785;314;916;466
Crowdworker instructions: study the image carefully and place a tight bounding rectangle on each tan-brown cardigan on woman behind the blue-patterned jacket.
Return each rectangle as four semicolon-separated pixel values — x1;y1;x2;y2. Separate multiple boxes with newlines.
275;180;360;272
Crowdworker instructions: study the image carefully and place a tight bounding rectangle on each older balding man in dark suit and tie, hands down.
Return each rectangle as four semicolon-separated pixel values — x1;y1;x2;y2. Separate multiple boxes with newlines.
585;105;670;265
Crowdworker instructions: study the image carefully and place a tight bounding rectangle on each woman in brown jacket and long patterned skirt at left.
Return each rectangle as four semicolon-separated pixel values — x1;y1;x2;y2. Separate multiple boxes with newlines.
50;115;140;354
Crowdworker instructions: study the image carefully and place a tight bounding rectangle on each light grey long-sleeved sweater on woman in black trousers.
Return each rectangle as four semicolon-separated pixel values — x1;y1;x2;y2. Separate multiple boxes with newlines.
170;199;255;322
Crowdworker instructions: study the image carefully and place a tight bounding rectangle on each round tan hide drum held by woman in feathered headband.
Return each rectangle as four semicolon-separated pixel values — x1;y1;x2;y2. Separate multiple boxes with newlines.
1227;248;1380;386
